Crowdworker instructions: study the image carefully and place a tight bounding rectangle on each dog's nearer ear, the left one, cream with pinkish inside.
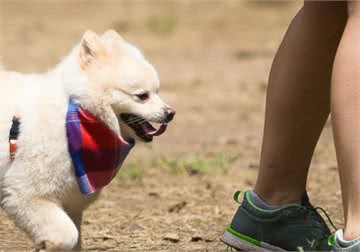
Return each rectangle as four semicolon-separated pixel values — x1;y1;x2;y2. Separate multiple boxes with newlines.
79;31;105;69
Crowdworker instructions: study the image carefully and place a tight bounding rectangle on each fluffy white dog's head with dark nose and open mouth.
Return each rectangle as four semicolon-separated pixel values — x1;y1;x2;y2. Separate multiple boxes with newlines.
75;30;175;142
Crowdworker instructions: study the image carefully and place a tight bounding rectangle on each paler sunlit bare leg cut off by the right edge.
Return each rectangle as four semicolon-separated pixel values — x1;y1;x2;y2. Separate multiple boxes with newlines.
331;1;360;240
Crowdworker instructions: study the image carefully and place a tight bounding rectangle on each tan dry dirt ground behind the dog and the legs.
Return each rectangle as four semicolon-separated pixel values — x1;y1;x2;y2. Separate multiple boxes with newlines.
0;0;342;251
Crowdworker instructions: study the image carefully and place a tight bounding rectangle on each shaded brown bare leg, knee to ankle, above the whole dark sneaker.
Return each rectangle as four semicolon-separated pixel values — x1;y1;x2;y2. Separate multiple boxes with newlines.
254;1;347;204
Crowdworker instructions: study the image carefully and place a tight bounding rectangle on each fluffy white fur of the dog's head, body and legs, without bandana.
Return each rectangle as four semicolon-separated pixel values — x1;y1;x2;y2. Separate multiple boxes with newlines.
0;30;169;251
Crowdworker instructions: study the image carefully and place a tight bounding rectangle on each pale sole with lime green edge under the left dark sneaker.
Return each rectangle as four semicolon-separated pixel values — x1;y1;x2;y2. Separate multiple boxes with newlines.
220;228;286;252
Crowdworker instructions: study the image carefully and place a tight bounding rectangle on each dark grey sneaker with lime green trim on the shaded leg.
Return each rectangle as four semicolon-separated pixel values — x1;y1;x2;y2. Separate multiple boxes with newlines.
221;191;331;251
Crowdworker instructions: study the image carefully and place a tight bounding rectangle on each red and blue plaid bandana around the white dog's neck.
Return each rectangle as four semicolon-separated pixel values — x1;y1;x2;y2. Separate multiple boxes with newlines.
66;98;134;195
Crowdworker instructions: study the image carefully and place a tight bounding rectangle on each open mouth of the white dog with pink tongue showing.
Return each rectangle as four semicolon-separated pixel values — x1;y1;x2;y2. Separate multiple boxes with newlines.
120;114;167;142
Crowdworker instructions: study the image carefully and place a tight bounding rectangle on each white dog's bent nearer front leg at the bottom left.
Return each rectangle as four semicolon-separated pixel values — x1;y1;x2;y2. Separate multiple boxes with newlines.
5;199;79;251
